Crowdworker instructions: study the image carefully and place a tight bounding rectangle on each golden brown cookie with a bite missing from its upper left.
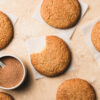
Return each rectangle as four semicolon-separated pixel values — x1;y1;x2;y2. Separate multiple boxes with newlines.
31;36;71;77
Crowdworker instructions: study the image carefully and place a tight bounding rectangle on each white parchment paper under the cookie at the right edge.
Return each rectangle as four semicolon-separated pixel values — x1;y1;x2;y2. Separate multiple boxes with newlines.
81;18;100;65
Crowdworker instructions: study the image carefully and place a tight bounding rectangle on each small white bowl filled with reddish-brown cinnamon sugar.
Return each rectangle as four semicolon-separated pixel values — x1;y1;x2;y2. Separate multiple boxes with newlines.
0;55;26;90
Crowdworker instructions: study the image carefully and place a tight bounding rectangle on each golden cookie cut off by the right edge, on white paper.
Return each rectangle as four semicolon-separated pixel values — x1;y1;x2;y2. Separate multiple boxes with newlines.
91;21;100;52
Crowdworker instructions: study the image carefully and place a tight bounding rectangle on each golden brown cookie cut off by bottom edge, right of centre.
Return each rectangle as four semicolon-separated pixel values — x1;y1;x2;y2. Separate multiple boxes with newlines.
56;79;96;100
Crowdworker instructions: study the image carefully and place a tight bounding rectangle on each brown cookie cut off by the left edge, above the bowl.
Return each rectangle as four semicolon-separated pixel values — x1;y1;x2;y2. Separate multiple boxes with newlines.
0;12;13;50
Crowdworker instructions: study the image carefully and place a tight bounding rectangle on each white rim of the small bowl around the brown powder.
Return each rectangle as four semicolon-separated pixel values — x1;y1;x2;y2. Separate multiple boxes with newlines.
0;54;26;90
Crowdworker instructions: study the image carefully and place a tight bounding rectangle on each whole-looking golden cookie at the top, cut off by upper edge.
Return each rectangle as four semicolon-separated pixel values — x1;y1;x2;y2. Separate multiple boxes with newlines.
40;0;81;29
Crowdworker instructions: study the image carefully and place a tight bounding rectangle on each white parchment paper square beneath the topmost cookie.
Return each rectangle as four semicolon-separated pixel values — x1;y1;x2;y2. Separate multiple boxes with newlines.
32;0;88;38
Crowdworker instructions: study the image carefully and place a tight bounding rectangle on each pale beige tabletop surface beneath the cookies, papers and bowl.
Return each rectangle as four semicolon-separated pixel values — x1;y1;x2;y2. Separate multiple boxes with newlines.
0;0;100;100
